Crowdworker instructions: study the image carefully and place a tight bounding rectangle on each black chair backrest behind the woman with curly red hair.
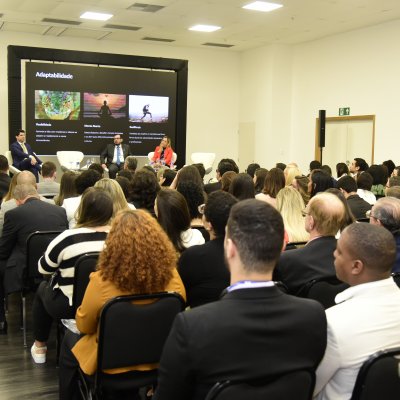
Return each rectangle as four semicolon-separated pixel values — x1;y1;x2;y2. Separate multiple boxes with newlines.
97;292;185;377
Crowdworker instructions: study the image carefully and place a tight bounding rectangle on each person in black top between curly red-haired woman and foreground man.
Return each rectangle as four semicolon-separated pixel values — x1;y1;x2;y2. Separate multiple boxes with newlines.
178;190;237;308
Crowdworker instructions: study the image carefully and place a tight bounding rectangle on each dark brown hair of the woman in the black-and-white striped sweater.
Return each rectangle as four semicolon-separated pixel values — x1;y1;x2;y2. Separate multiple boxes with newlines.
76;187;114;227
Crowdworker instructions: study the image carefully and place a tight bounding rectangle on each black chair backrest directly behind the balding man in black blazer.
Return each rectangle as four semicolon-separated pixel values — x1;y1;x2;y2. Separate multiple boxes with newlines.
296;278;349;309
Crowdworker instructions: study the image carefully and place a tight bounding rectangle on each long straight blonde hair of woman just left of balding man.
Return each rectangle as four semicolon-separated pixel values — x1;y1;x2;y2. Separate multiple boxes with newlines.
276;186;309;242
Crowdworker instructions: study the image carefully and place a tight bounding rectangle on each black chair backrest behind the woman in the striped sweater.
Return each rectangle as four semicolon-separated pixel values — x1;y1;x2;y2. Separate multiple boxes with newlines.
72;252;100;310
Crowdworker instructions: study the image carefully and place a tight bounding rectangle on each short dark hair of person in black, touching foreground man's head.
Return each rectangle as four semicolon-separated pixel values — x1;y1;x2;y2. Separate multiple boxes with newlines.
204;190;238;237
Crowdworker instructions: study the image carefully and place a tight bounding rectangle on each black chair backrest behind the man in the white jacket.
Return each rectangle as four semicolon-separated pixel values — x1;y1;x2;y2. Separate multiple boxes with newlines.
351;347;400;400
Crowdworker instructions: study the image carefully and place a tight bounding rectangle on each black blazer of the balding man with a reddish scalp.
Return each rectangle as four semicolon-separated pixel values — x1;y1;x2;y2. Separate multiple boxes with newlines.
273;236;336;294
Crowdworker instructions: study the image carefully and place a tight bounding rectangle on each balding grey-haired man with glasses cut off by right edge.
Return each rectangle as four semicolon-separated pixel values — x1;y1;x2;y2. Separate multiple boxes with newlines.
369;197;400;272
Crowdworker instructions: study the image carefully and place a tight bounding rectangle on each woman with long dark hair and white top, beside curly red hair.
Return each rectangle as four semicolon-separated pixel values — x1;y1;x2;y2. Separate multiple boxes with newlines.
154;188;205;253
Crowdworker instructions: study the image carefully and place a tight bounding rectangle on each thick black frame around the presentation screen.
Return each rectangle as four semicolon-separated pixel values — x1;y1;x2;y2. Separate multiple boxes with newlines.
7;45;188;167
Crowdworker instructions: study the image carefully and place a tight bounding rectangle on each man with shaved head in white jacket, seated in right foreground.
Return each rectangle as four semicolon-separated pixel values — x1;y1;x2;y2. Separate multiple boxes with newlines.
314;223;400;400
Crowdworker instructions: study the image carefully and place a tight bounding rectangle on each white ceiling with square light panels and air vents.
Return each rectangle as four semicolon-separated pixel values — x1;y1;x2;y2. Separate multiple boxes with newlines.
0;0;400;51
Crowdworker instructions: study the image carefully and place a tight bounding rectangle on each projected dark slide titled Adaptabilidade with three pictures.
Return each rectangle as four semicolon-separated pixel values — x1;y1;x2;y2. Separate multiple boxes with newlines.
25;62;177;156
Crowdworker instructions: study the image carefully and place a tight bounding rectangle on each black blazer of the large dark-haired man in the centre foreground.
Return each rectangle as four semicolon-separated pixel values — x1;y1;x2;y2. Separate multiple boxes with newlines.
153;286;327;400
